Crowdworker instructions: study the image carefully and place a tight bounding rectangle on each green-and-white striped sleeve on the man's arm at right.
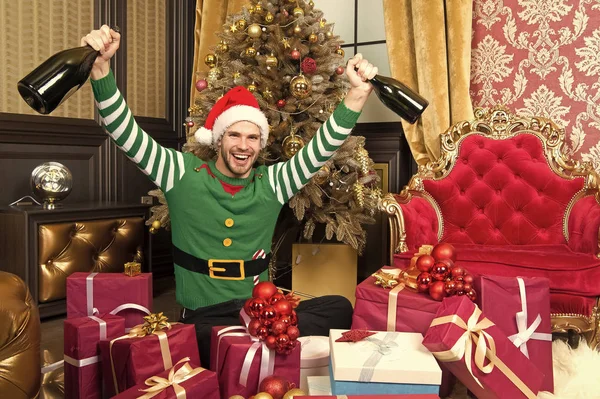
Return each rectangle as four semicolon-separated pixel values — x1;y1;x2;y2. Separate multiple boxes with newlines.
267;102;360;204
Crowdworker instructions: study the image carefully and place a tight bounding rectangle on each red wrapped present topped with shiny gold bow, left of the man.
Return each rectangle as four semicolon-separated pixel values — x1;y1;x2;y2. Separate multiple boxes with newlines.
100;313;200;395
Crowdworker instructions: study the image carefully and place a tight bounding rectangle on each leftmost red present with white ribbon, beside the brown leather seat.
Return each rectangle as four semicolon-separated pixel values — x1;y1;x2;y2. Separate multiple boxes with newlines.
64;314;125;399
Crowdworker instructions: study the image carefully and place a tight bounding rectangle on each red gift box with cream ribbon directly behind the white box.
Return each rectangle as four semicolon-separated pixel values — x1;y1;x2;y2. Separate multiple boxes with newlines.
352;267;456;396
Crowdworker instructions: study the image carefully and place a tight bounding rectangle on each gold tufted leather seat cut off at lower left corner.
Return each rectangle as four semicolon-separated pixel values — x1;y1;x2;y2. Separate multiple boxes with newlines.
0;271;41;399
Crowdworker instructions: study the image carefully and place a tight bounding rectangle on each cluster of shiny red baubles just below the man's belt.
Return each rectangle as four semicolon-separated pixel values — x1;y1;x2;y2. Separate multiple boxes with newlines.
244;281;300;354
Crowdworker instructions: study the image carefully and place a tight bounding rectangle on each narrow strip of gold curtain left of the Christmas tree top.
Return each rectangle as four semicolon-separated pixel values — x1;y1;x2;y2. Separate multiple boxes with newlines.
190;0;248;104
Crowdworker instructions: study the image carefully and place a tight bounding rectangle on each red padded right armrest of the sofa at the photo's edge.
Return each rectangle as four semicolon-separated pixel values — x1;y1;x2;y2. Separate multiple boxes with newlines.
567;195;600;257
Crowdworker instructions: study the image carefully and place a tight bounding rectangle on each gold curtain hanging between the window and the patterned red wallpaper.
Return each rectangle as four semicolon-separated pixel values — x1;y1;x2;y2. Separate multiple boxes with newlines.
383;0;473;165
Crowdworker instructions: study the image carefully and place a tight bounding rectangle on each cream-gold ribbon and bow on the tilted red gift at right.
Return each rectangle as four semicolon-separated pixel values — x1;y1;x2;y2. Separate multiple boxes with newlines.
430;307;537;399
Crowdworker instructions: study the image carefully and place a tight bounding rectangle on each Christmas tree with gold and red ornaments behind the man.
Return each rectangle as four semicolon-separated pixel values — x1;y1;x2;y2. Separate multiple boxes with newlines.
149;0;380;253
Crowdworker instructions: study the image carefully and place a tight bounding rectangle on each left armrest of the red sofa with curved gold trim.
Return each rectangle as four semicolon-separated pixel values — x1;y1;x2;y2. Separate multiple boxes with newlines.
380;194;439;262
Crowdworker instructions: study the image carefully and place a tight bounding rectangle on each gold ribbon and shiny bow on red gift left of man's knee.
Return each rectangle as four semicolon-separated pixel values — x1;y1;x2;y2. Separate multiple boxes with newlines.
108;312;179;393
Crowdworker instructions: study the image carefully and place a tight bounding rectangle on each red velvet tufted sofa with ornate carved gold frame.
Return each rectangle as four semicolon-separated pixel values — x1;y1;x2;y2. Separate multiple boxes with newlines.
380;107;600;346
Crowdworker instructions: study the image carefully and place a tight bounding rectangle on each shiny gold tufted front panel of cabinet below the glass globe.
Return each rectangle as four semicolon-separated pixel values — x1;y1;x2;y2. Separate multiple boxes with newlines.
38;217;144;303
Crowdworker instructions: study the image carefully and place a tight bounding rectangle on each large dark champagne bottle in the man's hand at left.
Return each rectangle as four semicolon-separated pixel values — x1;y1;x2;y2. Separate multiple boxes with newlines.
17;27;118;115
